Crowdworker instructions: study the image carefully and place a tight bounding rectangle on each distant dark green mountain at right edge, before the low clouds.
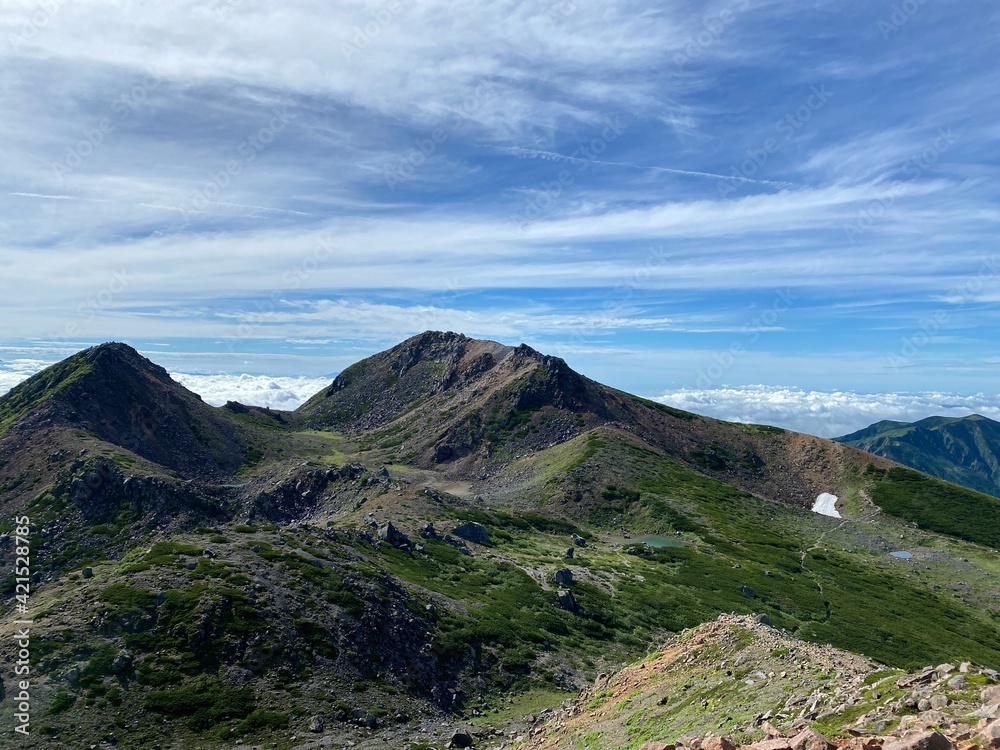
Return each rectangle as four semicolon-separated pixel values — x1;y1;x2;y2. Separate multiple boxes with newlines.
836;414;1000;497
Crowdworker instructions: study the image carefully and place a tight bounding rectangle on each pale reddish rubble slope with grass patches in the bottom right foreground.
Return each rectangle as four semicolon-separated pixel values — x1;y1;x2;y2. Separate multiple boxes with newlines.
517;615;1000;750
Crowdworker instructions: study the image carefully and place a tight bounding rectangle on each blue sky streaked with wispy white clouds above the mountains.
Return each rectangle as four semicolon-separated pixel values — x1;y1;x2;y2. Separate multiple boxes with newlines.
0;0;1000;431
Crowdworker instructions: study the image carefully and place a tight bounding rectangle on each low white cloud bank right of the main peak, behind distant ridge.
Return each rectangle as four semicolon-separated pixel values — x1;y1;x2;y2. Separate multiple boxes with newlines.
657;385;1000;437
